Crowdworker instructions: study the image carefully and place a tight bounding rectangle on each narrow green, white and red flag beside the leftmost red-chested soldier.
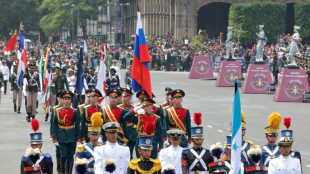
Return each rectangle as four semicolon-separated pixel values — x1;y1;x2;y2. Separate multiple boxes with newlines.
43;48;52;114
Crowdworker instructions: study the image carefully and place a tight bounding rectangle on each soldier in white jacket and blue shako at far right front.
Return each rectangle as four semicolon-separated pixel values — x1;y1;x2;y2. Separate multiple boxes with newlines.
268;120;302;174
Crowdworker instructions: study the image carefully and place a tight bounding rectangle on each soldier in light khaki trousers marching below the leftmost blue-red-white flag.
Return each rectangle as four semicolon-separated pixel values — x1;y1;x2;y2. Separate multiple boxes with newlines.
24;64;41;122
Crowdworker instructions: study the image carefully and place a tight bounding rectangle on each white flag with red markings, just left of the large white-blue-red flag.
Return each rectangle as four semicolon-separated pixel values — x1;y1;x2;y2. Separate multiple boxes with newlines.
97;44;108;106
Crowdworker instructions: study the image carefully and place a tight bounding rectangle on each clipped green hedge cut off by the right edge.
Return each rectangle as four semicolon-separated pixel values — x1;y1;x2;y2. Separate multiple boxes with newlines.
295;3;310;41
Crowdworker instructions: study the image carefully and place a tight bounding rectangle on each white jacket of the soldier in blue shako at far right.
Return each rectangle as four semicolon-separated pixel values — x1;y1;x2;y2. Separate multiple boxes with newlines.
268;155;301;174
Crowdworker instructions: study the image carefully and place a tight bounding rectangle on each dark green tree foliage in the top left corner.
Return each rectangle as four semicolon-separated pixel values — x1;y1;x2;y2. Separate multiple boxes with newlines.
0;0;41;40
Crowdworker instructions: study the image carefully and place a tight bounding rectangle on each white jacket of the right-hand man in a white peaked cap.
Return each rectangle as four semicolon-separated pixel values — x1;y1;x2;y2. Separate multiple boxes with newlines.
159;145;183;173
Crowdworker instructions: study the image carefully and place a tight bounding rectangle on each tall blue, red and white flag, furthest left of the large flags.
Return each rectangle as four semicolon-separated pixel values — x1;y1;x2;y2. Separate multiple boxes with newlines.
17;23;27;88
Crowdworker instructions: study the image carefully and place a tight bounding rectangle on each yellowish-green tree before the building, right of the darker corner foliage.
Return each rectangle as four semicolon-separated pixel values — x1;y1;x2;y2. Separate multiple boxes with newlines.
40;0;106;38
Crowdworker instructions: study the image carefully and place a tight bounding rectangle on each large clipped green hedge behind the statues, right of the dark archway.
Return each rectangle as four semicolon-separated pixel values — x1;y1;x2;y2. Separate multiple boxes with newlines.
229;2;286;42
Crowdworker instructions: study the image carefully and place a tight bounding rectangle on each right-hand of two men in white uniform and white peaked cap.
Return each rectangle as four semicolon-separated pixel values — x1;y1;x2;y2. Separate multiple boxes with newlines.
159;129;184;173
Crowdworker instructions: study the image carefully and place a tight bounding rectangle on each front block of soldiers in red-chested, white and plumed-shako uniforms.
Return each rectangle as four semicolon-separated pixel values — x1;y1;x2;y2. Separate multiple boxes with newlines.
17;75;302;174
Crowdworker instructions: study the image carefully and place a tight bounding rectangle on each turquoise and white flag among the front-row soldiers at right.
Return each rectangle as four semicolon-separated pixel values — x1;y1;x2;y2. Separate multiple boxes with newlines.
231;79;242;174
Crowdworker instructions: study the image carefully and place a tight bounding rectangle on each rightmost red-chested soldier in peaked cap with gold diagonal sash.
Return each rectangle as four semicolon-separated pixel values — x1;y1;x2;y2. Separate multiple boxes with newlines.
165;89;191;147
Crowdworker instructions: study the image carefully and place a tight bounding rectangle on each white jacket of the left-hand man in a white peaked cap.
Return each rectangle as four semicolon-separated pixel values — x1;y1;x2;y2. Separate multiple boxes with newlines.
94;141;130;174
